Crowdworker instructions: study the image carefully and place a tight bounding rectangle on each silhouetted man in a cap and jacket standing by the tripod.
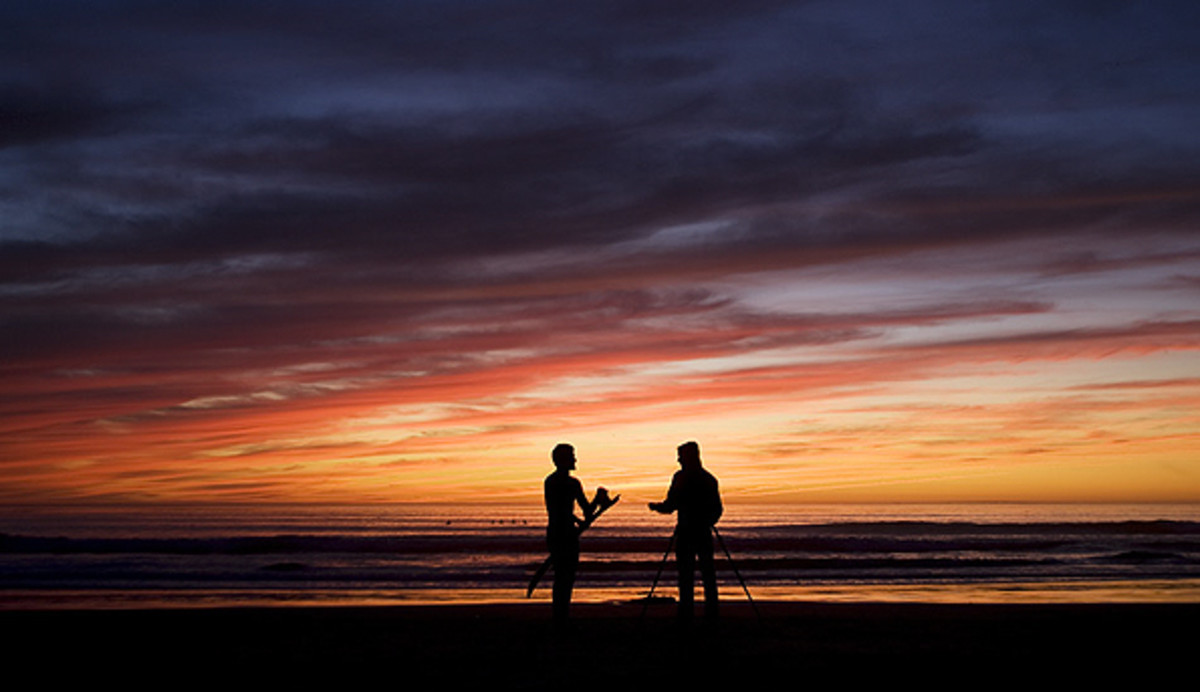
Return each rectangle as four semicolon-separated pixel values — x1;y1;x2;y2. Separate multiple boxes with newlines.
650;443;724;622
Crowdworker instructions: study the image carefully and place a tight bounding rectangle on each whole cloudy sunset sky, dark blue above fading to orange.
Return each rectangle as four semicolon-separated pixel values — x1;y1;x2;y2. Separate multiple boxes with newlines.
0;0;1200;504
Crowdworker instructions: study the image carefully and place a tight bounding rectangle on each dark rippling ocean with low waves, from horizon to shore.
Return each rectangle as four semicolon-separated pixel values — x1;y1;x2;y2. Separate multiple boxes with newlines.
0;503;1200;609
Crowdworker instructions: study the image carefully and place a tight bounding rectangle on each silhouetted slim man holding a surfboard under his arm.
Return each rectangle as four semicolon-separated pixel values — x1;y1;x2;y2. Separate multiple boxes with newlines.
545;444;599;626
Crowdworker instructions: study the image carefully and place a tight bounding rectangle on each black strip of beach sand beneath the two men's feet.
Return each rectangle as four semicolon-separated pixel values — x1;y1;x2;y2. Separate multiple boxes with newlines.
7;602;1200;690
